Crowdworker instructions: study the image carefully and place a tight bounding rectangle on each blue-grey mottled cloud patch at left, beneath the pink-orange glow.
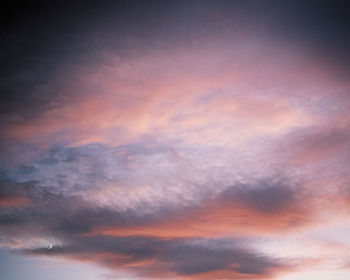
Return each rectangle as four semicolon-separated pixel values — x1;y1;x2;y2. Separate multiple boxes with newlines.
0;139;176;191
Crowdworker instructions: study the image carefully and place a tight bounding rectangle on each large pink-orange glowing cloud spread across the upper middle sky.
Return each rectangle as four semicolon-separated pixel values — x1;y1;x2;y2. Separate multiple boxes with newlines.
4;43;328;148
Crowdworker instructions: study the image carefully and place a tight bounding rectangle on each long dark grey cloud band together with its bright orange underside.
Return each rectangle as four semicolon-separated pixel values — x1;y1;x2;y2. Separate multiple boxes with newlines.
0;165;318;246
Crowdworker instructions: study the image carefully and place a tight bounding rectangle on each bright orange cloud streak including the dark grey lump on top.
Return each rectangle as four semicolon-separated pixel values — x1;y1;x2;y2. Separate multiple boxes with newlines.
93;182;314;238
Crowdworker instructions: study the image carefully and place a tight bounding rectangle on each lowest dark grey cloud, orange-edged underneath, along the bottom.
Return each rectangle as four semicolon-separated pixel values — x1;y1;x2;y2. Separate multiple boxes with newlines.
22;236;287;279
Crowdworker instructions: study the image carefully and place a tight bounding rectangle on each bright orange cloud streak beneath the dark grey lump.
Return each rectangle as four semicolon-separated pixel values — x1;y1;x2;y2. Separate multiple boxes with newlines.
88;188;320;238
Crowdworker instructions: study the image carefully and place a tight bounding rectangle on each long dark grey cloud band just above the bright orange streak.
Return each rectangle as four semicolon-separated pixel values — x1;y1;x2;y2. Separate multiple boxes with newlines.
0;166;305;241
